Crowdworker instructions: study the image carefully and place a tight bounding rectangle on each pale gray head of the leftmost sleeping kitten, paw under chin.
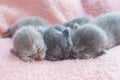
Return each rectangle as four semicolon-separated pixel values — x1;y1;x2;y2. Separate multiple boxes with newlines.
11;26;47;62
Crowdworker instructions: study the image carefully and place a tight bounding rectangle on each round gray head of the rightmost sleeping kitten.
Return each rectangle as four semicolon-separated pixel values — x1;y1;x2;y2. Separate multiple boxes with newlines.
72;24;107;59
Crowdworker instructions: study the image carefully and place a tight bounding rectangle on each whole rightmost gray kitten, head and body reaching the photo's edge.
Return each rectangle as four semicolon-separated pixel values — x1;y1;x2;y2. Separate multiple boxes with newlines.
72;13;120;59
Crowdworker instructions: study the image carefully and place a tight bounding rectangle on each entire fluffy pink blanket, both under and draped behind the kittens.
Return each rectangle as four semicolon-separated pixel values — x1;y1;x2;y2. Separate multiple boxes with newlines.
0;0;120;80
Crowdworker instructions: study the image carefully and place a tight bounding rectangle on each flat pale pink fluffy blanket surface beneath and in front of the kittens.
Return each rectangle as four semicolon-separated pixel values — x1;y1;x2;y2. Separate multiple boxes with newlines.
0;39;120;80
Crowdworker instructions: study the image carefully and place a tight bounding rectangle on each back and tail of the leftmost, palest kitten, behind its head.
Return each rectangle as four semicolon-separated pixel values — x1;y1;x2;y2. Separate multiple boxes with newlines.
2;16;49;38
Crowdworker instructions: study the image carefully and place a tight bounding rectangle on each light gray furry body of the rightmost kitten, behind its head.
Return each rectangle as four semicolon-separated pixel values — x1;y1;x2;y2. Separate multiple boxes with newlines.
93;13;120;49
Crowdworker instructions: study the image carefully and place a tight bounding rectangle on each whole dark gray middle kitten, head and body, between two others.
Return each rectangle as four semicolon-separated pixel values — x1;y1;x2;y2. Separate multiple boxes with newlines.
43;16;92;61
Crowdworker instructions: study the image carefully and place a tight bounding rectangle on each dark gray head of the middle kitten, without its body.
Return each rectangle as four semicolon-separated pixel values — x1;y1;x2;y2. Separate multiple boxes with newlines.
43;27;73;61
